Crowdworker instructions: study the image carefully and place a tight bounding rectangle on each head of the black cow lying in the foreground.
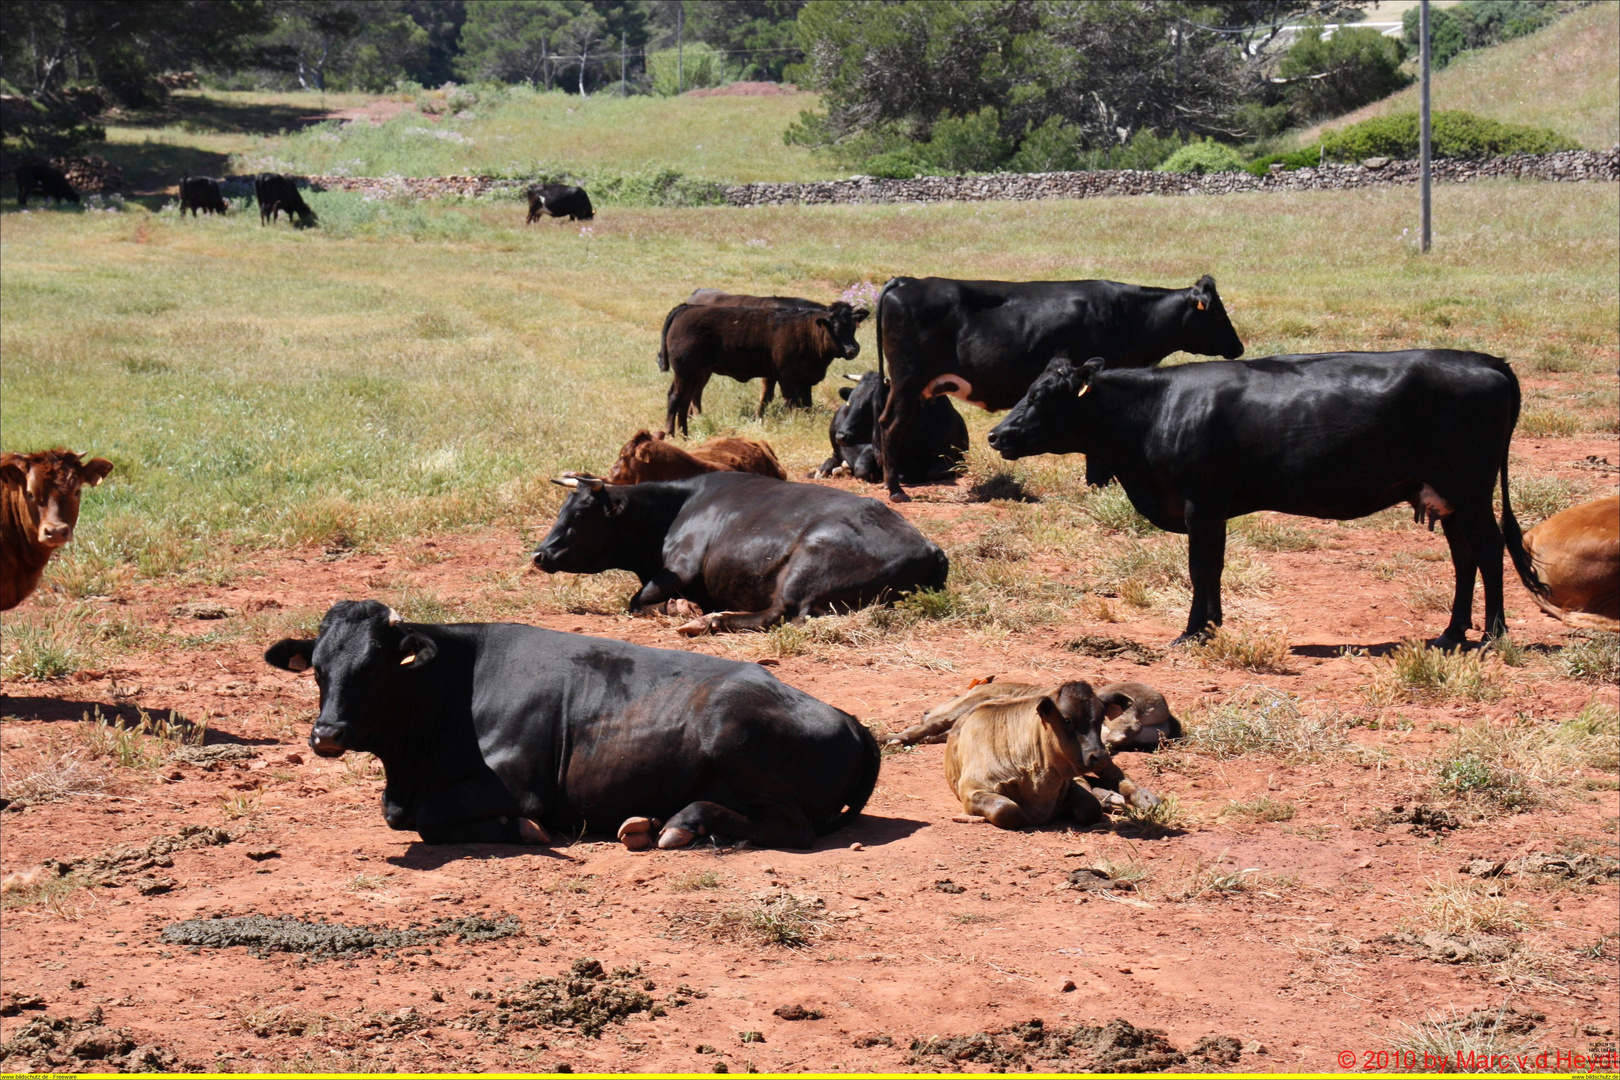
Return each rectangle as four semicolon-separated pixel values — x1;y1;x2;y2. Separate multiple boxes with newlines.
264;601;439;758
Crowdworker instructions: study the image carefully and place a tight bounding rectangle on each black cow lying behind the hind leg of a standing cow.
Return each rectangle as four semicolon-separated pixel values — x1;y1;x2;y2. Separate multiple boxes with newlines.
813;371;967;484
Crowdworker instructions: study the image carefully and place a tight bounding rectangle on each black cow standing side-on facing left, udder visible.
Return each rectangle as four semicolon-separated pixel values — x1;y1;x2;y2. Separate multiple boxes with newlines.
990;348;1545;648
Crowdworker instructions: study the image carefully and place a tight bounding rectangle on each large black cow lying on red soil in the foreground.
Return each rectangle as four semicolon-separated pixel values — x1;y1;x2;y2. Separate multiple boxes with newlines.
264;605;878;850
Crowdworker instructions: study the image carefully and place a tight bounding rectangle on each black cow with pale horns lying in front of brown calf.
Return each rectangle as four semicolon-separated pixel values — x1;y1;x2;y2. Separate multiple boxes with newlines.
535;473;949;636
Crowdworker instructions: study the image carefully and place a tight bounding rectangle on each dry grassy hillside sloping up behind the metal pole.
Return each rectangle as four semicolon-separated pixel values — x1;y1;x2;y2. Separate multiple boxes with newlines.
1299;3;1620;149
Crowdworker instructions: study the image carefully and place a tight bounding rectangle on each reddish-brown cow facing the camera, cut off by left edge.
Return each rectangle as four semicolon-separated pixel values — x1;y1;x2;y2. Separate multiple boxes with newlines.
0;450;112;610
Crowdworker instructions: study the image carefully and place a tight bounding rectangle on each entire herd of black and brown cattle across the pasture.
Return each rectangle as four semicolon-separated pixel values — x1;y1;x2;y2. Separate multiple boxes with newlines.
0;170;1620;850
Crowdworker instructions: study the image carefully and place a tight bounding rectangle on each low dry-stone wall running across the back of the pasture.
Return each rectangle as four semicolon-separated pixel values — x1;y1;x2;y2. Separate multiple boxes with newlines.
281;146;1620;206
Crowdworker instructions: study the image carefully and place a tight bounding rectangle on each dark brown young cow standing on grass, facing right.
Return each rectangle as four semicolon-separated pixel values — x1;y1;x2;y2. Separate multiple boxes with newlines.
658;301;865;434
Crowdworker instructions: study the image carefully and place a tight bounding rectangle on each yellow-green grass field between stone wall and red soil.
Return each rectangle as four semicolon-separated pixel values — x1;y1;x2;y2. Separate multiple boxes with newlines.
0;182;1620;595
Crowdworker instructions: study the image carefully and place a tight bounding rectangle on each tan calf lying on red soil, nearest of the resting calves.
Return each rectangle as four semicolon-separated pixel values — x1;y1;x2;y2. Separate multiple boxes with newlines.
944;682;1158;829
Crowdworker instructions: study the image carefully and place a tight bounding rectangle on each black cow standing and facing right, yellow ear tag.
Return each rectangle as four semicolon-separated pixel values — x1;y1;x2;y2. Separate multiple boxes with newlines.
878;275;1243;502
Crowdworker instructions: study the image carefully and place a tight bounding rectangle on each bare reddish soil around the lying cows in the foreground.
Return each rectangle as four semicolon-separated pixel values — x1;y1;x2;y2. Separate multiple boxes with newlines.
0;439;1620;1072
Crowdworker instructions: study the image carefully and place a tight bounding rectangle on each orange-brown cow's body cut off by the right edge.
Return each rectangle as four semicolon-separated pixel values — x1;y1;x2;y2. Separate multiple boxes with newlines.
1524;495;1620;630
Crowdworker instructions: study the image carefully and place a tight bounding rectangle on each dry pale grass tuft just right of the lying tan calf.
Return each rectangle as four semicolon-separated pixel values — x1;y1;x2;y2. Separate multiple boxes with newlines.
1183;687;1375;763
